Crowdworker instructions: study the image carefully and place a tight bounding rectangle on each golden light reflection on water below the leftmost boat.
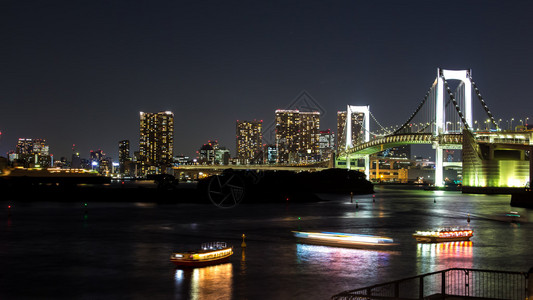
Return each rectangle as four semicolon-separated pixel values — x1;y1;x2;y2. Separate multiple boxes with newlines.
174;263;233;299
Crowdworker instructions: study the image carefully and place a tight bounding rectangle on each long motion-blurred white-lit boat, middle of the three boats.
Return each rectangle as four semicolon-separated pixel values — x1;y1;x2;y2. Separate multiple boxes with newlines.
293;231;396;249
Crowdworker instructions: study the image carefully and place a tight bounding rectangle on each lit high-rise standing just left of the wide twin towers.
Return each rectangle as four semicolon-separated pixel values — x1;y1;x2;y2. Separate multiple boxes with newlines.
236;120;263;164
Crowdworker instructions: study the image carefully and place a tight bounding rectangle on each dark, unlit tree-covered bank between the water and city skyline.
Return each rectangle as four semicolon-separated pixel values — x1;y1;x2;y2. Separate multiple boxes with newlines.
0;169;374;206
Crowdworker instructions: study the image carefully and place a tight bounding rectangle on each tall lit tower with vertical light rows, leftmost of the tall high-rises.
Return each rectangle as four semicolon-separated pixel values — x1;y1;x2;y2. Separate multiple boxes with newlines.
139;111;174;175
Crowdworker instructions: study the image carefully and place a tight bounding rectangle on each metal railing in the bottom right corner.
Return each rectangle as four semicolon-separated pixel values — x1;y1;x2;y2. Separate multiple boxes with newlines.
331;268;533;300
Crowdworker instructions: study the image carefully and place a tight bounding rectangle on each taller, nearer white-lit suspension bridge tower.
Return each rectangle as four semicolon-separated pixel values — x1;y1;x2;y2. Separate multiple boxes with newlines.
432;68;472;186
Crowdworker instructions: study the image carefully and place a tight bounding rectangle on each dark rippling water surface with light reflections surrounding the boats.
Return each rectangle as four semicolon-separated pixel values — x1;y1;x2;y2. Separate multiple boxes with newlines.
0;187;533;299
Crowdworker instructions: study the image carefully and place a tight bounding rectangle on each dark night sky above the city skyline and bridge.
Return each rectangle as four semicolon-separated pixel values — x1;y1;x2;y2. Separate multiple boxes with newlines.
0;0;533;160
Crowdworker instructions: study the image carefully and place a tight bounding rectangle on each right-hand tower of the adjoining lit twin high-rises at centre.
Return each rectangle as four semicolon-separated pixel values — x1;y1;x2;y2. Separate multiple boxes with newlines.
298;111;320;162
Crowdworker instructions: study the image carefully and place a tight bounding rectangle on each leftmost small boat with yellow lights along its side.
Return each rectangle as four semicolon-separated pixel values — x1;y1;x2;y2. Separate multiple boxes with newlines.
170;242;233;267
